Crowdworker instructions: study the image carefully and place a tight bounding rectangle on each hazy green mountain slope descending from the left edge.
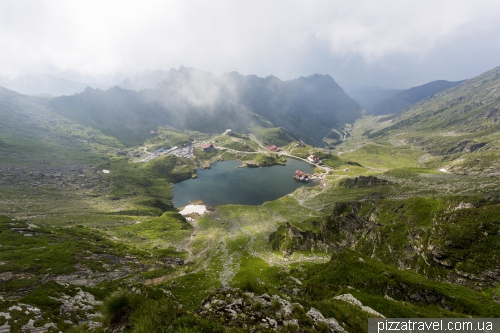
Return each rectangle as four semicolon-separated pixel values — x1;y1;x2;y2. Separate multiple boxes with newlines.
0;87;123;166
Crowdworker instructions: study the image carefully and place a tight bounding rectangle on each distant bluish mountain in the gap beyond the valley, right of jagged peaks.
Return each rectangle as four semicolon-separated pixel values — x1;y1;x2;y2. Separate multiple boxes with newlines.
348;80;463;116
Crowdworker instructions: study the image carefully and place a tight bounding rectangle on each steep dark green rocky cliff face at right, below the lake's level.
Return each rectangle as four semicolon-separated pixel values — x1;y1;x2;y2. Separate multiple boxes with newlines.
270;192;500;288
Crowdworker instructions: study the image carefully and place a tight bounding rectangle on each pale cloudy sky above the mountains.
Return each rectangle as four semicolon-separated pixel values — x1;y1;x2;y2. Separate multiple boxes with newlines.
0;0;500;88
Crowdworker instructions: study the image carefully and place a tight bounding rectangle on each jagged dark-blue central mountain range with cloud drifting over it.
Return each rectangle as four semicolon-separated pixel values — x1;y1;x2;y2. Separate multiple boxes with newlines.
47;67;361;145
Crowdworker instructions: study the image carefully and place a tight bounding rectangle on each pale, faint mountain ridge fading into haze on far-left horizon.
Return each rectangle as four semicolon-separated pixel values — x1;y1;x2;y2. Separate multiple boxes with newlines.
0;73;110;96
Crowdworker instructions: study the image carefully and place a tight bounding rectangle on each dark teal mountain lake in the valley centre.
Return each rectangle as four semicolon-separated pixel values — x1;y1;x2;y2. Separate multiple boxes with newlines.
173;158;317;207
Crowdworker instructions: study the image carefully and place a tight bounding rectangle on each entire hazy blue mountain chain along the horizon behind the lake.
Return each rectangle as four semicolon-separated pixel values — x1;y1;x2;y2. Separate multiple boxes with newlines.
1;67;468;146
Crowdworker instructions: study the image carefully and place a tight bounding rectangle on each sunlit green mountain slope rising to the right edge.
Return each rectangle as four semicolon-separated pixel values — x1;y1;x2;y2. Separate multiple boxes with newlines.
365;67;500;172
